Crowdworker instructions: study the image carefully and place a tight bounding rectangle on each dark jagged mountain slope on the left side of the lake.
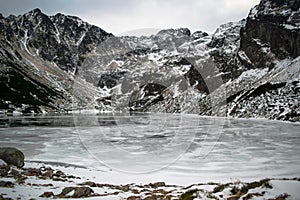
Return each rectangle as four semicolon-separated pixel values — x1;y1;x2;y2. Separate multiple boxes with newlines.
0;9;111;112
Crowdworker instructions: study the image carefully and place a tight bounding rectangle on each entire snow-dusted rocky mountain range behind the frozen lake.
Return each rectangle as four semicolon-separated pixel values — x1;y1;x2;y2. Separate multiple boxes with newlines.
0;0;300;121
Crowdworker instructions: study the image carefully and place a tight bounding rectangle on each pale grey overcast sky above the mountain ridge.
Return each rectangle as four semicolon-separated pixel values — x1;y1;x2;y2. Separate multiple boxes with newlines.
0;0;259;35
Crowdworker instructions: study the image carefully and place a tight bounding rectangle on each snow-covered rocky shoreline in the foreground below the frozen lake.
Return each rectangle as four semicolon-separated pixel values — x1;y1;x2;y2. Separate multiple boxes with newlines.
0;162;300;200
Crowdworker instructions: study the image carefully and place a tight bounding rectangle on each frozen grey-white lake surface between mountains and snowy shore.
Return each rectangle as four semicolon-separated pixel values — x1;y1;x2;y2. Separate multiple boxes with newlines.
0;113;300;185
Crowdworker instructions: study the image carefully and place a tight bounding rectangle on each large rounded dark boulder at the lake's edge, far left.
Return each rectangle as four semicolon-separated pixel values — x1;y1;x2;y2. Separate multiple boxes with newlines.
0;147;24;168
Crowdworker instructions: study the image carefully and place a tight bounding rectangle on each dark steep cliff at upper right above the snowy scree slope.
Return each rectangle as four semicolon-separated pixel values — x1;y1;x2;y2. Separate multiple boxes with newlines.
239;0;300;68
